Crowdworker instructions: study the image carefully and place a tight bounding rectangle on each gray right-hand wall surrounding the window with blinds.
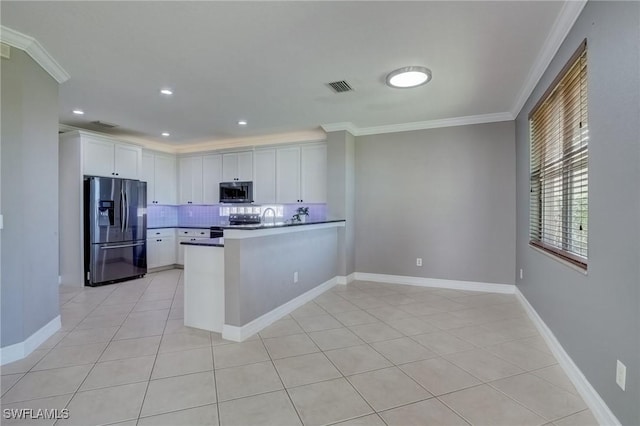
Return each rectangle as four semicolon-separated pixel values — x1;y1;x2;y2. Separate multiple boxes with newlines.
516;2;640;425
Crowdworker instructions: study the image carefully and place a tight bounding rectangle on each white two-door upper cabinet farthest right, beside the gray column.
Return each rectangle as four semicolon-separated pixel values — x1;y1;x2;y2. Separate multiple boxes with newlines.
276;144;327;203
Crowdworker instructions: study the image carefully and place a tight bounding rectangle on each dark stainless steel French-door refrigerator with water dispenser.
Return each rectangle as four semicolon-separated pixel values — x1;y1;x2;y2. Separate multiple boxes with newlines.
84;177;147;286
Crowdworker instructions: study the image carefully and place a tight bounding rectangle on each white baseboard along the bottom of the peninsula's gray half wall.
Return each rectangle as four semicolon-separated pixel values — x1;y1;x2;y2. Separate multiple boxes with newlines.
222;277;337;342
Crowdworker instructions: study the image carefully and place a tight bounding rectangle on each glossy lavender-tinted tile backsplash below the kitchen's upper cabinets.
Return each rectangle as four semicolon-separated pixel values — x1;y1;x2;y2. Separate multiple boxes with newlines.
147;203;327;228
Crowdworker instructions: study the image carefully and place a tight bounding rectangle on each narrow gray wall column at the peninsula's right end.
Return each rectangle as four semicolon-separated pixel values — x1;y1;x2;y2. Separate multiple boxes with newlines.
327;131;355;276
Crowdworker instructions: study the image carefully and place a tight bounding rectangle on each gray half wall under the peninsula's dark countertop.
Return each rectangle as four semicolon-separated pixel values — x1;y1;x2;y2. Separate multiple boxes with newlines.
224;228;339;326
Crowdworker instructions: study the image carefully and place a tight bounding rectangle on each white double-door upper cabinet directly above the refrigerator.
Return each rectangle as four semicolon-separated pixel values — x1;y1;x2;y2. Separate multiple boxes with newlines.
80;133;142;179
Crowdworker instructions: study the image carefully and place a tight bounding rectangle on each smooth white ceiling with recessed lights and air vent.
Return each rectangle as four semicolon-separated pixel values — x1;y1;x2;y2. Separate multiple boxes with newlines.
0;0;577;148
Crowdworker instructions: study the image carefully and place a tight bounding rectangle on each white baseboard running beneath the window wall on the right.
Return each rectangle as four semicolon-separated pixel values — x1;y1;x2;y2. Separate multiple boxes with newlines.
515;288;620;426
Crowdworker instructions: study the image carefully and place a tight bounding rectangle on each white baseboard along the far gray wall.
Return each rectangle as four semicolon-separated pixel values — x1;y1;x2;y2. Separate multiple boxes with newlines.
355;272;516;294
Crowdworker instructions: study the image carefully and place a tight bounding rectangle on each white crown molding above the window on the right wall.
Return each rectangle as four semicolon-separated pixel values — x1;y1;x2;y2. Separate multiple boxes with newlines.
511;0;587;117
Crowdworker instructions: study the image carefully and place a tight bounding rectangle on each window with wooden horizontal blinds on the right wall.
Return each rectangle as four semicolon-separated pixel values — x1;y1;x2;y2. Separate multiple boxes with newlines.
529;40;589;269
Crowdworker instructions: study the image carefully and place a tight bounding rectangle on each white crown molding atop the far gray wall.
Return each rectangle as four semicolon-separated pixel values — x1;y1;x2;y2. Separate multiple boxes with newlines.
322;112;514;136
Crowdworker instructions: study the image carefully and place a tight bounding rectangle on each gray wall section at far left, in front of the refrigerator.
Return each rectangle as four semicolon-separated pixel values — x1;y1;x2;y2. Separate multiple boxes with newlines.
0;48;59;347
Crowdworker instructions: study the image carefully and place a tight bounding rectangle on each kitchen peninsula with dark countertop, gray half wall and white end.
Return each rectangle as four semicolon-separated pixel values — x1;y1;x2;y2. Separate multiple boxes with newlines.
182;220;345;342
